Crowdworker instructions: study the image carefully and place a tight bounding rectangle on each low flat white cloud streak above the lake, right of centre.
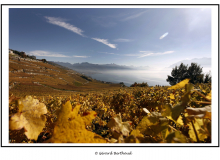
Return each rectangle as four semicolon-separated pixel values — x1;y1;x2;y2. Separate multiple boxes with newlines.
124;51;174;58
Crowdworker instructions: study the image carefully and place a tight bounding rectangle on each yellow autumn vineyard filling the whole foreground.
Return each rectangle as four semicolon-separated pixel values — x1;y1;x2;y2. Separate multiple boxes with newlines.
9;79;211;143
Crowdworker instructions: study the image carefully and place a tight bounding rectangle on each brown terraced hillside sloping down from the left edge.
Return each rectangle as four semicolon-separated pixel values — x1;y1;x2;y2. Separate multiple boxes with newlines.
9;55;120;96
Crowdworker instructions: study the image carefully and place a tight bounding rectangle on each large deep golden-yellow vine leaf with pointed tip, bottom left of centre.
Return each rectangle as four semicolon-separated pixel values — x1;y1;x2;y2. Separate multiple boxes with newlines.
48;101;106;143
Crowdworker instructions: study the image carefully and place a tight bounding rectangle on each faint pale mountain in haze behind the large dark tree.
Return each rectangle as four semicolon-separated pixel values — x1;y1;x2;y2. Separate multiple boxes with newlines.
169;57;211;68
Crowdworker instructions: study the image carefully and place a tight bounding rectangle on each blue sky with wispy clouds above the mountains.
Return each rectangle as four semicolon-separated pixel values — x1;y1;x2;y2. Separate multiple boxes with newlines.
9;8;211;67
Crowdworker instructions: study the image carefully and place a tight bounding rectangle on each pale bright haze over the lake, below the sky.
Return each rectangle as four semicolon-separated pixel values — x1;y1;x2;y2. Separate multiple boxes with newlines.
53;58;211;86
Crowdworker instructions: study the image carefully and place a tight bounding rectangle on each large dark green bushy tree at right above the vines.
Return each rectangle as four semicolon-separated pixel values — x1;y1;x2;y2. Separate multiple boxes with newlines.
166;63;206;85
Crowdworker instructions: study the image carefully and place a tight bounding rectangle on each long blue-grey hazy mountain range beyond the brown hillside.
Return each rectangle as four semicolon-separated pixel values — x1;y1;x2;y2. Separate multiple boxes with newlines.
50;62;149;73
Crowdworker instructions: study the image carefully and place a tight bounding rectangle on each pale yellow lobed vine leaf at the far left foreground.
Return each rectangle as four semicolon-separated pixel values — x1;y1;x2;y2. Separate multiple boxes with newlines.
9;96;47;140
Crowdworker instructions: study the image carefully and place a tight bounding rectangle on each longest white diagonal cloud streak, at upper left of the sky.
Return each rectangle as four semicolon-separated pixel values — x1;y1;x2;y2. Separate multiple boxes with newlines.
45;16;85;37
